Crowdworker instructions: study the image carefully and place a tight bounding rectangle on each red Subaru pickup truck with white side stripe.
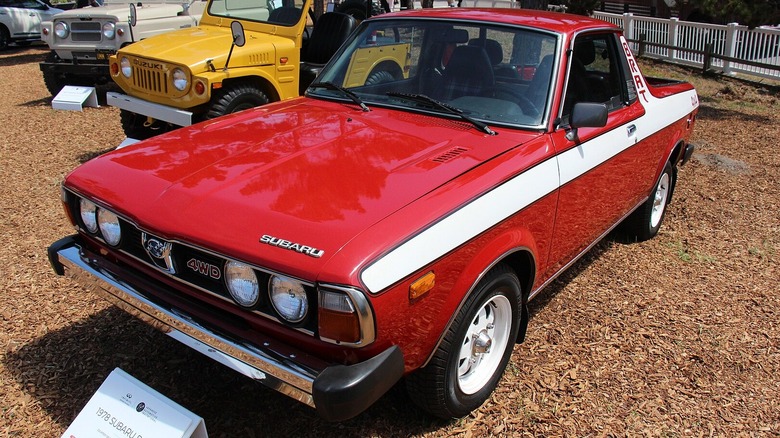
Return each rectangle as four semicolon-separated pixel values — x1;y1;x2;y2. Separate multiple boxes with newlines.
49;8;699;421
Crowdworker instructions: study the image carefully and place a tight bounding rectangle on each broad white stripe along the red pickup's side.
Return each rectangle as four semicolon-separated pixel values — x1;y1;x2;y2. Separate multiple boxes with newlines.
360;46;698;293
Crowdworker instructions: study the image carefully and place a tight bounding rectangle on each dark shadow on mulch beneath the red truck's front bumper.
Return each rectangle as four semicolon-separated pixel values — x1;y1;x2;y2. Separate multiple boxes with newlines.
4;307;454;437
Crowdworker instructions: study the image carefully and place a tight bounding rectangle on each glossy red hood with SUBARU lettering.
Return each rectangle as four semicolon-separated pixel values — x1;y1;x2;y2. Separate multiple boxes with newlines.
66;98;539;280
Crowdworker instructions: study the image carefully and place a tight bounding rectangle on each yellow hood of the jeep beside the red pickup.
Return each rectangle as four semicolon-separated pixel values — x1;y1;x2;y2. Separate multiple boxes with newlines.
119;26;284;69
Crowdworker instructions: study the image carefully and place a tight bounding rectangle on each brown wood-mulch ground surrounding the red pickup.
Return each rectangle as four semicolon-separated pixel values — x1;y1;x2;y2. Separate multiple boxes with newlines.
0;46;780;437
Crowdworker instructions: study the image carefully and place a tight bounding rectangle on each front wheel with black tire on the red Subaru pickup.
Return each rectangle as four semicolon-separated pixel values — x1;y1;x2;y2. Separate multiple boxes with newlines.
406;265;522;418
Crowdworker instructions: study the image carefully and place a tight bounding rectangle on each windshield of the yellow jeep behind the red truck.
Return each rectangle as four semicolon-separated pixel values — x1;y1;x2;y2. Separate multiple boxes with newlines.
209;0;303;26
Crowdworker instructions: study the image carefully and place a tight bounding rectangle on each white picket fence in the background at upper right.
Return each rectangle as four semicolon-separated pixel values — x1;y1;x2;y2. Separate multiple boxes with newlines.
593;11;780;79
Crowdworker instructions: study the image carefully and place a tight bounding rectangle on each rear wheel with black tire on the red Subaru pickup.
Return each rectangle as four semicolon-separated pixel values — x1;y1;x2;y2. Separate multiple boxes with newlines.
620;162;677;242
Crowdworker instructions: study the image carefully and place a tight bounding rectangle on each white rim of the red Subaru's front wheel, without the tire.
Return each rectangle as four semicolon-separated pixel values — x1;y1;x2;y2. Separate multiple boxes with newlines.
458;295;512;395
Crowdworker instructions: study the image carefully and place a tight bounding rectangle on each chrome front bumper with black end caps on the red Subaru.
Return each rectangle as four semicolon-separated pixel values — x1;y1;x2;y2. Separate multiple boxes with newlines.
49;236;404;421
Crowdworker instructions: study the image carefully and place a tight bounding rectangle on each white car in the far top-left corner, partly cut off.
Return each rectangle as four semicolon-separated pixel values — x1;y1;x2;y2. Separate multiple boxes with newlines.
0;0;62;50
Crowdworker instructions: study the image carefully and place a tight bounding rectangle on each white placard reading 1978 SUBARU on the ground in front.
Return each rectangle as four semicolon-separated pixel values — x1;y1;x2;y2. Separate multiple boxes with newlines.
62;368;208;438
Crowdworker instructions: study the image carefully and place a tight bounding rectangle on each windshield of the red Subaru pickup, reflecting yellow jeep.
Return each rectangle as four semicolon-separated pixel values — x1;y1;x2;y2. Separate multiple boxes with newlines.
308;19;558;127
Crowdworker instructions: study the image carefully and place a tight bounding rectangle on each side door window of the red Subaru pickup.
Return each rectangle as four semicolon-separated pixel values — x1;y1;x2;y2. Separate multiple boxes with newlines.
563;33;635;119
